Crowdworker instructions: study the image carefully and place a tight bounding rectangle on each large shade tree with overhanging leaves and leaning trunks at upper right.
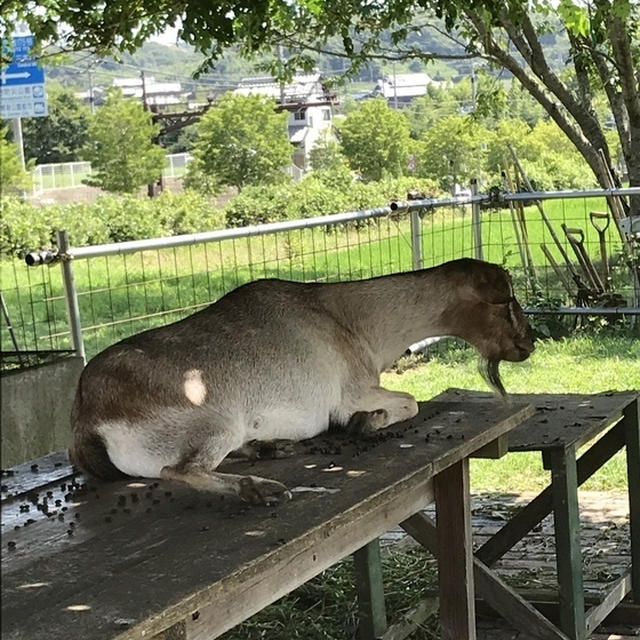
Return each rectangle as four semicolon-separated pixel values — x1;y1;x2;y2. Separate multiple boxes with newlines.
0;0;640;208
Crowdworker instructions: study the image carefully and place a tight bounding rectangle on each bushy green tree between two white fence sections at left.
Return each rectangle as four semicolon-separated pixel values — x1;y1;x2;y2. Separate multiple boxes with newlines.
85;89;165;193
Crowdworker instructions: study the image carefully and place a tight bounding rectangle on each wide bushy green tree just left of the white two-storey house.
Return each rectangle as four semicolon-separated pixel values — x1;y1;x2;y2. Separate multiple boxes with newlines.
184;93;293;191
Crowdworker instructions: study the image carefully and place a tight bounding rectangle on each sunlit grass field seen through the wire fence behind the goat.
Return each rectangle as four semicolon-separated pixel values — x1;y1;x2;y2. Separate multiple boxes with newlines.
0;192;630;356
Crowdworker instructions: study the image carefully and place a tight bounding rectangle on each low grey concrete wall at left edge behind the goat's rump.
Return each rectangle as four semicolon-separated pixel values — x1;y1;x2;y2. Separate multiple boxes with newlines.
0;357;83;469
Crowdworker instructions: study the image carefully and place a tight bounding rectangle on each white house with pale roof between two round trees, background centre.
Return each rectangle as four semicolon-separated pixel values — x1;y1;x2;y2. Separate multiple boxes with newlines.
234;72;337;170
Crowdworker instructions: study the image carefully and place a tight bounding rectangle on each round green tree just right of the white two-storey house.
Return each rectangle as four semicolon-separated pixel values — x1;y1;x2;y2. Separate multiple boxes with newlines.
339;98;410;180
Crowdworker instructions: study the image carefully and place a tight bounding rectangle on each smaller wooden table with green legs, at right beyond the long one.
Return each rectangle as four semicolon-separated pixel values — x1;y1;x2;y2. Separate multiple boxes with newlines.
441;389;640;640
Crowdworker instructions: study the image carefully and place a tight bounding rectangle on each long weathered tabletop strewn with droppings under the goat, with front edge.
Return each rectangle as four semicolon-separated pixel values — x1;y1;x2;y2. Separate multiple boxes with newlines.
2;390;532;640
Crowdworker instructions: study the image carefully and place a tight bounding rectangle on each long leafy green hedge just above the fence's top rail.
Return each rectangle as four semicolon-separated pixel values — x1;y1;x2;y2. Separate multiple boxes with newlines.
0;168;437;257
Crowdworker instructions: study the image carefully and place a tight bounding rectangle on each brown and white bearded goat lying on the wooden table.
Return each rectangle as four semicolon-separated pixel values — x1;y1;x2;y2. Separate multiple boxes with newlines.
69;259;534;504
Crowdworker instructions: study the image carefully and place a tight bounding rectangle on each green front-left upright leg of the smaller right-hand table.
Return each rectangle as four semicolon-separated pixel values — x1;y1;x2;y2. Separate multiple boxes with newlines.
545;448;585;640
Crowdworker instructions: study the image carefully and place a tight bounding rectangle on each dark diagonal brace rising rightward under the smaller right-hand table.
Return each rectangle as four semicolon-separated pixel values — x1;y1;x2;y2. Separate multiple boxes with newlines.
476;423;625;566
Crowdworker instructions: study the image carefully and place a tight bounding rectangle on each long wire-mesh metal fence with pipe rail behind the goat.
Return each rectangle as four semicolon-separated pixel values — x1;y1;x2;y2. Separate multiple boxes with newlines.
2;188;640;364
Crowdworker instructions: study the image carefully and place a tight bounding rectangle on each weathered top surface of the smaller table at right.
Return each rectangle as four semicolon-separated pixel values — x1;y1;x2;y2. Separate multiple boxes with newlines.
441;389;638;451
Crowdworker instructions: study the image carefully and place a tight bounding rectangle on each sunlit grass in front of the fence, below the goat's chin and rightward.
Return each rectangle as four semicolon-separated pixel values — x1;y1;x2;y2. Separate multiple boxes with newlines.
382;335;640;492
